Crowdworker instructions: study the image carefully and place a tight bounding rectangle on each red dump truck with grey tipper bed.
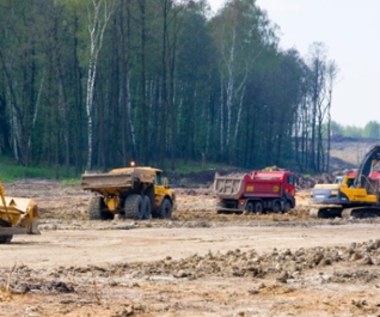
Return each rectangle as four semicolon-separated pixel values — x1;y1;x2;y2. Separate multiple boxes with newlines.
214;171;296;213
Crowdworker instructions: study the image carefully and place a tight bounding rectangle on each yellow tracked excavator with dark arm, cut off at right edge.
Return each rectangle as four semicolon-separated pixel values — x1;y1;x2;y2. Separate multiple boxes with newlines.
310;145;380;218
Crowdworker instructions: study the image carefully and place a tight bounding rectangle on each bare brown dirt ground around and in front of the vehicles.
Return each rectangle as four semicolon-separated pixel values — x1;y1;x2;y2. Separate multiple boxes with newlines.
0;181;380;317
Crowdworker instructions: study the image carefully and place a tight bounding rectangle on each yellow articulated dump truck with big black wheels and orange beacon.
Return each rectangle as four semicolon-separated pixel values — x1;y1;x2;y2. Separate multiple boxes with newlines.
81;166;175;220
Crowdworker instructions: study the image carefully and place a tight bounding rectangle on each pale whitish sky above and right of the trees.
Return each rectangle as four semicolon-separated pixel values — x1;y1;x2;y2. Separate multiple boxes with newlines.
208;0;380;127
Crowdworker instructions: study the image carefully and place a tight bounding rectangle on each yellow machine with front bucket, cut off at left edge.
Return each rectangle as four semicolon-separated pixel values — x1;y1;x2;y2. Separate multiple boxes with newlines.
0;183;40;244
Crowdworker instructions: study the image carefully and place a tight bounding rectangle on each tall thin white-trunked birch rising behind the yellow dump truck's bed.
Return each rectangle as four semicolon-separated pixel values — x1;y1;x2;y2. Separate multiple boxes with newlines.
86;0;113;170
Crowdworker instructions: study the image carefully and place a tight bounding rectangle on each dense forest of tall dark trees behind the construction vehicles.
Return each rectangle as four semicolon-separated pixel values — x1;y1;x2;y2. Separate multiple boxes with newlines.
0;0;337;173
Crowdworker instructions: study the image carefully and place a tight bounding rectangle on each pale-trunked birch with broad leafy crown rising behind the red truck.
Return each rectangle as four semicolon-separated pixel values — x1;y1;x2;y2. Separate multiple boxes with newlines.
212;0;275;160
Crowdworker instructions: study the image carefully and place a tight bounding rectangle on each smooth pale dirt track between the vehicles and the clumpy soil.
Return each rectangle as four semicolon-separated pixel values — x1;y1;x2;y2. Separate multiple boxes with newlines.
0;222;380;269
